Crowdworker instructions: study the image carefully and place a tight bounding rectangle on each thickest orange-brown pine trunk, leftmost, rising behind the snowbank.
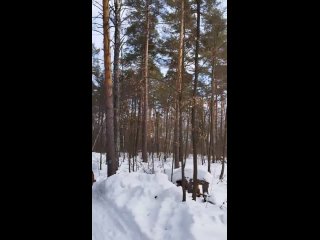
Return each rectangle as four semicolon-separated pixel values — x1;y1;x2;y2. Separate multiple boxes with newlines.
102;0;118;177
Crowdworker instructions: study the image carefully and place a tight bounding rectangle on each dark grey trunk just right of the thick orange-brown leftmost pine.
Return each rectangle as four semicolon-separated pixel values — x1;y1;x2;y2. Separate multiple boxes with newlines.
113;0;121;163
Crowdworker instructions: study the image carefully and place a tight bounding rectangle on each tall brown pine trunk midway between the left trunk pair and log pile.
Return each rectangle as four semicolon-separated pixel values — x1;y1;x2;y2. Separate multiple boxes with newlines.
142;0;150;162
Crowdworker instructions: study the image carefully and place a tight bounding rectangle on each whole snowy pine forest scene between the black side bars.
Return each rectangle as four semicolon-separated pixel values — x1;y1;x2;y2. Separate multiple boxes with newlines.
92;0;228;236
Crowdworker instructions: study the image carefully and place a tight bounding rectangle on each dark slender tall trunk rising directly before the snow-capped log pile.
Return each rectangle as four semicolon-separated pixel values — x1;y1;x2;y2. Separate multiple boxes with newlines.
191;0;200;201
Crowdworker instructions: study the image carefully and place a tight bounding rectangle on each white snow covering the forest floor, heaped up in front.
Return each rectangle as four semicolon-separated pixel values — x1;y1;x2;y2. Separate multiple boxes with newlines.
92;153;227;240
